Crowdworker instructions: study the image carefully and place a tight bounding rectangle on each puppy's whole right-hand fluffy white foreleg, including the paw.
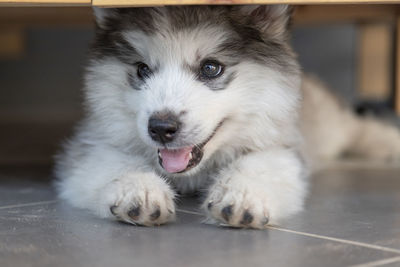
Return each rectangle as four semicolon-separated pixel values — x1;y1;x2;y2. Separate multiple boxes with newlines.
204;149;306;228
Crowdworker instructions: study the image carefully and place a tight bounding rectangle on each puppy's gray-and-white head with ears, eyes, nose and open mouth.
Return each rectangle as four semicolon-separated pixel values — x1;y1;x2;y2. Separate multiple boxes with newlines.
87;6;298;174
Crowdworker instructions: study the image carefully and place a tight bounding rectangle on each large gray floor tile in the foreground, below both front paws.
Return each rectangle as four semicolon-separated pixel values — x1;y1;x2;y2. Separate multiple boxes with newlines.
0;203;396;267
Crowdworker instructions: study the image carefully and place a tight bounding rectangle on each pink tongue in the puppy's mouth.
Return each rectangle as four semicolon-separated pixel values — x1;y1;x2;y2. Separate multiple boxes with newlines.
160;147;192;173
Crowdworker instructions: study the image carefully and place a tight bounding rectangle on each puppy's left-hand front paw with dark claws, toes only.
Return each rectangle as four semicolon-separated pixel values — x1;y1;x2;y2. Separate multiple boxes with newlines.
110;175;175;226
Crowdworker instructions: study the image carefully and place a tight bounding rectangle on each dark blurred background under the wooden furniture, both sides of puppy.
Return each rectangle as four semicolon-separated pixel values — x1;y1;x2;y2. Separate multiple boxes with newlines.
0;5;398;172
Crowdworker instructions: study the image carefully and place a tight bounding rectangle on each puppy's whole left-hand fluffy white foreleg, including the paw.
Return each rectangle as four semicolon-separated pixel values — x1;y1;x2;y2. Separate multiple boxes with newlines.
58;146;175;225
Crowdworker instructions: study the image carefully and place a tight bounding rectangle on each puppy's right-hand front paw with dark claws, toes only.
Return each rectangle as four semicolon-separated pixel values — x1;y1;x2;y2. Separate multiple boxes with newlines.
203;181;270;229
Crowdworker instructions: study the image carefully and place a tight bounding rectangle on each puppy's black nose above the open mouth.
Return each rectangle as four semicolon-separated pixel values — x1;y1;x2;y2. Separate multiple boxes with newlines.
148;113;180;144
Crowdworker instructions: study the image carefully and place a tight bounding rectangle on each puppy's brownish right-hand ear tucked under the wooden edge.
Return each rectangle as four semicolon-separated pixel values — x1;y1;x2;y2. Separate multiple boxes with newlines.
236;5;293;40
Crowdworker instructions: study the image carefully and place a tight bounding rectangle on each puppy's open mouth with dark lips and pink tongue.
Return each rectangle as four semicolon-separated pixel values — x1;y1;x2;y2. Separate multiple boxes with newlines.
158;121;223;173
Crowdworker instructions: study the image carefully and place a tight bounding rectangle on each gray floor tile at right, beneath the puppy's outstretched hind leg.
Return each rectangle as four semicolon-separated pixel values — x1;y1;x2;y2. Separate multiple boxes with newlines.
283;169;400;250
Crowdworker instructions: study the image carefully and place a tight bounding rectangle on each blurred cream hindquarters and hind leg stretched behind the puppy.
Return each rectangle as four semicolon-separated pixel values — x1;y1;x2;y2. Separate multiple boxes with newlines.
301;76;400;170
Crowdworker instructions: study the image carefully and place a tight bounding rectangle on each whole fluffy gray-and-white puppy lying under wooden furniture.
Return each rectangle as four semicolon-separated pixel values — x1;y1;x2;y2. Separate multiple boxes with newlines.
56;5;400;228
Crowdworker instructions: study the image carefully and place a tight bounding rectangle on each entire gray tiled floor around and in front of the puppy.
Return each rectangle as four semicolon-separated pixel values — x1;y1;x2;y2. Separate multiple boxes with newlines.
0;166;400;267
